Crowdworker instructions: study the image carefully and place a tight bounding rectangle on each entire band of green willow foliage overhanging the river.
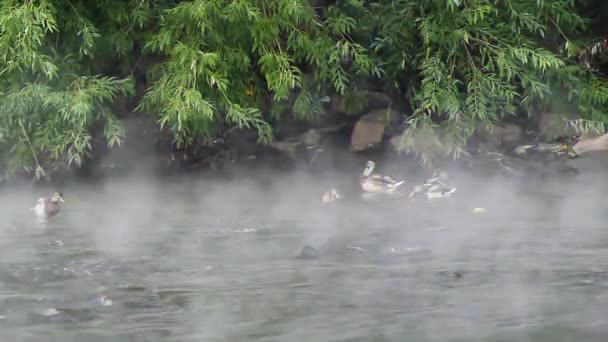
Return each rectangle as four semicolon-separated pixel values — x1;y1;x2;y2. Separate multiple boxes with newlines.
0;0;608;180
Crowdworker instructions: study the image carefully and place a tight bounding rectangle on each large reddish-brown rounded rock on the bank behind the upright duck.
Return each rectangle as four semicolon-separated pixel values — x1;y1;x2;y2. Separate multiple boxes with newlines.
350;108;398;152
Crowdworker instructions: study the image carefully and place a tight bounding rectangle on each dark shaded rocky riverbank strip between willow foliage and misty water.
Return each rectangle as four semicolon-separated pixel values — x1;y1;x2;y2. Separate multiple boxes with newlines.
0;103;608;187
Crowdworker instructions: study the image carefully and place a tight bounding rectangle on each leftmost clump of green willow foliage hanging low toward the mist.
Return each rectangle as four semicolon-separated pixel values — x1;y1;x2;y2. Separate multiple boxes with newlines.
0;0;139;177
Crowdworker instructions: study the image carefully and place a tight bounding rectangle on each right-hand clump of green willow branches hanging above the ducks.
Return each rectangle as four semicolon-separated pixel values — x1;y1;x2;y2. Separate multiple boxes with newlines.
361;0;608;162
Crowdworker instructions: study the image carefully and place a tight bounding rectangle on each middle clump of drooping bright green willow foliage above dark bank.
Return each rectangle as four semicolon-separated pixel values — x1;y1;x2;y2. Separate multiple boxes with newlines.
140;0;380;146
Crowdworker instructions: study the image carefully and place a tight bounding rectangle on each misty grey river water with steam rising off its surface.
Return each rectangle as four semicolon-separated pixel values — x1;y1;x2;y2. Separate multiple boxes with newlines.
0;169;608;342
